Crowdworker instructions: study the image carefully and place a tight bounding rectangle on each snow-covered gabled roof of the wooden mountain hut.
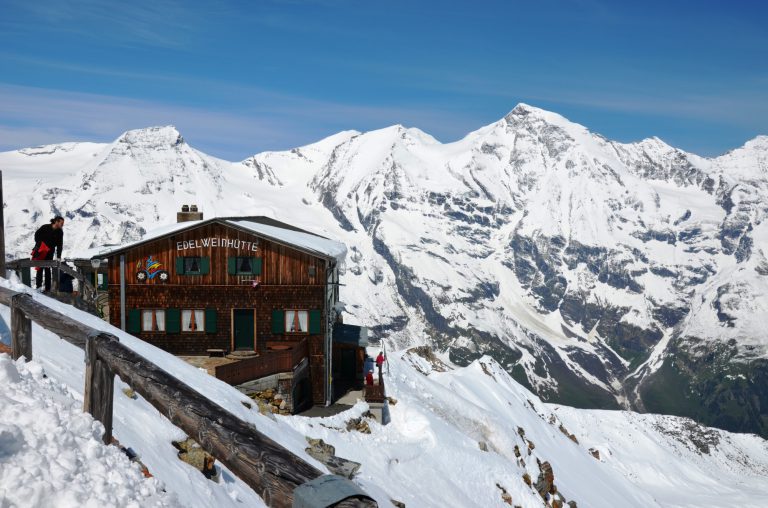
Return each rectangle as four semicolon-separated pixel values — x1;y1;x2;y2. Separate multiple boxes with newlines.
76;217;347;263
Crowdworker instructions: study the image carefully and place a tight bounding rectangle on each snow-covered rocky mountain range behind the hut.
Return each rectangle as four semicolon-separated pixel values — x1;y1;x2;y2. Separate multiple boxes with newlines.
0;104;768;435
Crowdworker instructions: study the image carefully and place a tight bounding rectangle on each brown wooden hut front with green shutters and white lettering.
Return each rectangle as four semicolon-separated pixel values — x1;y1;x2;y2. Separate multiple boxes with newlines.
106;219;338;404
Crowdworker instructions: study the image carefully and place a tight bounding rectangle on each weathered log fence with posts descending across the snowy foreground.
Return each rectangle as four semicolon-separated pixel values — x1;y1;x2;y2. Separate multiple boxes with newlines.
0;287;377;507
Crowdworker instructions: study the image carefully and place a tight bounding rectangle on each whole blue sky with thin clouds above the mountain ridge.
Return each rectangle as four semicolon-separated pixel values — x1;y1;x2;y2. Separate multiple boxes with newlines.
0;0;768;160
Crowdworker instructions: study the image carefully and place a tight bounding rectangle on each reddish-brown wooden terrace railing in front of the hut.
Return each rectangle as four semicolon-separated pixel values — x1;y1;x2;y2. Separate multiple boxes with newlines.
216;339;309;385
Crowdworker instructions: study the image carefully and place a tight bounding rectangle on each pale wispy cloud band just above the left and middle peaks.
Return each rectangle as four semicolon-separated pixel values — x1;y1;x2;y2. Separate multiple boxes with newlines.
0;84;484;160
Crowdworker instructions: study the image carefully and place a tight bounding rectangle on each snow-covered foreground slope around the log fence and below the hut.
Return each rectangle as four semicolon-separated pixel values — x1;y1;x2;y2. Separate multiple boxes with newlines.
0;282;768;508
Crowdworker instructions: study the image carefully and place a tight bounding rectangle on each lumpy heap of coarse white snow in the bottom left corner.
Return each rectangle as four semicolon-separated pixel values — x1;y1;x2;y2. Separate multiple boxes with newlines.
0;354;181;508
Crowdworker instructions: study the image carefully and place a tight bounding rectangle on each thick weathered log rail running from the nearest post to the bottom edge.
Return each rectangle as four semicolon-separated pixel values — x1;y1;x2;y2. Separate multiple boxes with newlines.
96;341;322;507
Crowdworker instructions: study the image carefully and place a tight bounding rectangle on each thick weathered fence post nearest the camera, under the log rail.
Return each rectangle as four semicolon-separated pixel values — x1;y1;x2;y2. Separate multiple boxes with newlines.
83;333;118;444
